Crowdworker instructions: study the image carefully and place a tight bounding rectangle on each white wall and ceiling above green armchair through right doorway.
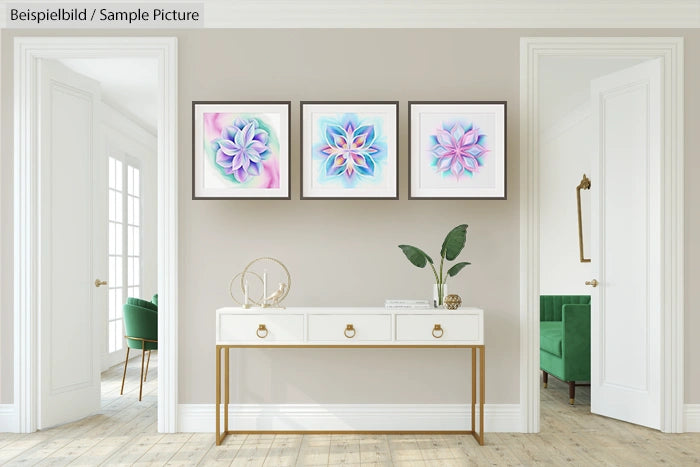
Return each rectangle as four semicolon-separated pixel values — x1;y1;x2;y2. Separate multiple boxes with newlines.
539;57;643;295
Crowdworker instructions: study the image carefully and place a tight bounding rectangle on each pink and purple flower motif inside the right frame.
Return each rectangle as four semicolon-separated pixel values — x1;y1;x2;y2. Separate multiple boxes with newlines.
430;121;489;180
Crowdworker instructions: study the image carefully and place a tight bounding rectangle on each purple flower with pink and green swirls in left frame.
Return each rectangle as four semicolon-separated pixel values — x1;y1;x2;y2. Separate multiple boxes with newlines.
204;113;280;188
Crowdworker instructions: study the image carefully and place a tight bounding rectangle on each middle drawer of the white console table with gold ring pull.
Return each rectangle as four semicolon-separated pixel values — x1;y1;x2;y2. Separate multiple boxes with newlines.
309;314;391;344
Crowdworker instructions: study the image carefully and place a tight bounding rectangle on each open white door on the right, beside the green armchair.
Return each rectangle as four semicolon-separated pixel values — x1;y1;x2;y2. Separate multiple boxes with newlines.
590;60;663;429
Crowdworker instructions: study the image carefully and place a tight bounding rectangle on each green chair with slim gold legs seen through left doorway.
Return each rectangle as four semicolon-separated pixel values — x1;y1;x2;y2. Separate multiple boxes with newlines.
120;304;158;400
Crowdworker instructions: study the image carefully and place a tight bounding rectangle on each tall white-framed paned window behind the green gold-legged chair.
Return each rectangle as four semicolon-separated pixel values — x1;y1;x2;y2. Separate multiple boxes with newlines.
107;156;141;353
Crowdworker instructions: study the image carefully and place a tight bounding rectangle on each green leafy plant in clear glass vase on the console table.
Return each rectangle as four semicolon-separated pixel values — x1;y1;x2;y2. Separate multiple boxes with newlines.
399;224;471;306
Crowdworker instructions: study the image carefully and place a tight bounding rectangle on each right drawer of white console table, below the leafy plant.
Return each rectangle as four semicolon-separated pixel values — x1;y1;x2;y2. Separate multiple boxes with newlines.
396;313;483;345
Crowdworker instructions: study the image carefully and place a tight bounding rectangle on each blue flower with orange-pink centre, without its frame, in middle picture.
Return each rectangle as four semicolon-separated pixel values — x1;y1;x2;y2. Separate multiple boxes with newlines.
314;114;386;188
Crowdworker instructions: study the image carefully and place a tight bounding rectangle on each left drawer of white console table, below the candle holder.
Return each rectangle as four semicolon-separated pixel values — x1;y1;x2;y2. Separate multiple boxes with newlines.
218;314;304;344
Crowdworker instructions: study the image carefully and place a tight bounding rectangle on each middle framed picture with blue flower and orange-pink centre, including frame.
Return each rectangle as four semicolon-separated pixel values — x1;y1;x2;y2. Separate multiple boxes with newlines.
301;101;399;199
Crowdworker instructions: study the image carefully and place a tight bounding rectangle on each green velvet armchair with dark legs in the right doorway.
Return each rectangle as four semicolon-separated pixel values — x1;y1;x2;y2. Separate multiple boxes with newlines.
540;295;591;405
